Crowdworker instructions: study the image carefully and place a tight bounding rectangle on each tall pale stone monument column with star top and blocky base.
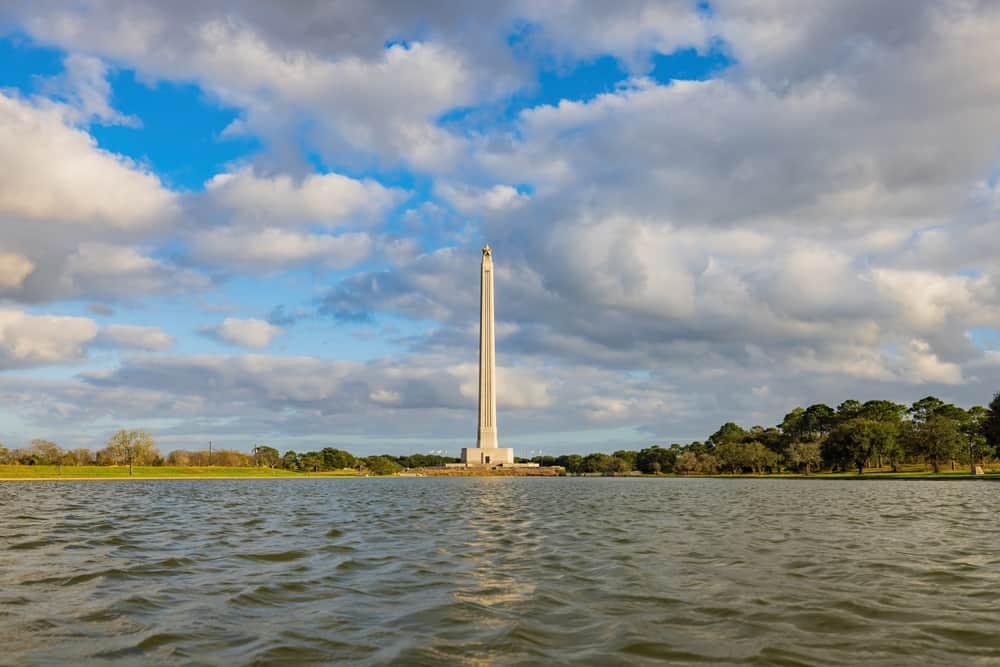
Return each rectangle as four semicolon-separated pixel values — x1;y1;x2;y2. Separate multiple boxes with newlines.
462;246;514;466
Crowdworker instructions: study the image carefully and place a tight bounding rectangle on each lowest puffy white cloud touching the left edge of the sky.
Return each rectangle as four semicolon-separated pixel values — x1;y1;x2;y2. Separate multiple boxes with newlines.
0;309;97;368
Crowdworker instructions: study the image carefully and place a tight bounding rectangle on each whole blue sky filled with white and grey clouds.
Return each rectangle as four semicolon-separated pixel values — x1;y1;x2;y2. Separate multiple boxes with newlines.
0;0;1000;454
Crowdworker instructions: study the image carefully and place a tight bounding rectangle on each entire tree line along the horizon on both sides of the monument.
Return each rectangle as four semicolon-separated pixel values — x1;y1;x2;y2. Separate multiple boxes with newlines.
0;392;1000;475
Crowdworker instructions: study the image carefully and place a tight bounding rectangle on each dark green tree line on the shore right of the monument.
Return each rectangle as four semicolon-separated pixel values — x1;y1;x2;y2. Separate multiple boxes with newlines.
531;392;1000;475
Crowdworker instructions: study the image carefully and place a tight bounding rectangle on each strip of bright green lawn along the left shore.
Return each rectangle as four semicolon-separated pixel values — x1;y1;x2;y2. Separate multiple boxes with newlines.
0;465;357;479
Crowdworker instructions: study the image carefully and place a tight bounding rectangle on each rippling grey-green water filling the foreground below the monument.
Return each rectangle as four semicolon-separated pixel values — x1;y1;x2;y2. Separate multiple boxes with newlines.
0;478;1000;666
